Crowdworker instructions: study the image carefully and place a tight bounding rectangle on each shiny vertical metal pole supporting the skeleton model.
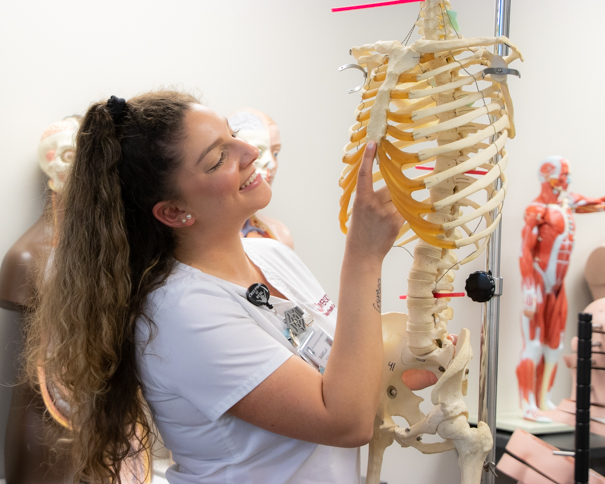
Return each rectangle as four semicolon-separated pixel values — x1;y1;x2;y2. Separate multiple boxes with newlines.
479;0;511;484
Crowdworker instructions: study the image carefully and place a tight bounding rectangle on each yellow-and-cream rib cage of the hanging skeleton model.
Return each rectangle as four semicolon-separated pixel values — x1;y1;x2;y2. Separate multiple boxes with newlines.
339;41;510;258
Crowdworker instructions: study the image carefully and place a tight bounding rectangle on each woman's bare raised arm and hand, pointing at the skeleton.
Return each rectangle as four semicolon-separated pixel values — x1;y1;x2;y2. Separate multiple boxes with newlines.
229;143;403;447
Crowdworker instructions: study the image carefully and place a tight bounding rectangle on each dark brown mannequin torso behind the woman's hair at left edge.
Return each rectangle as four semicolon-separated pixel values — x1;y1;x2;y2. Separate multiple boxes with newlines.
0;199;73;484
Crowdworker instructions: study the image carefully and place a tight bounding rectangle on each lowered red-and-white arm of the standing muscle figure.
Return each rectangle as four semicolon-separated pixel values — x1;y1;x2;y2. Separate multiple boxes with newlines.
519;204;545;318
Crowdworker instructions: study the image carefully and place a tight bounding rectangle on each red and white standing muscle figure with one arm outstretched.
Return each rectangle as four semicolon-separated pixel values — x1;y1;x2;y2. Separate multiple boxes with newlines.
517;156;605;422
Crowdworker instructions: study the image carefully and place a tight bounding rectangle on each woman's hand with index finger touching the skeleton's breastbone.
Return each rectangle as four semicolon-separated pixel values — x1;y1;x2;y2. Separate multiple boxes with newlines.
347;141;404;261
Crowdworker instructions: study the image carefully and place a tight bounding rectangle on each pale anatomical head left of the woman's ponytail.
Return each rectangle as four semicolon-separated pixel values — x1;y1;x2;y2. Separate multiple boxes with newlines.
38;116;80;193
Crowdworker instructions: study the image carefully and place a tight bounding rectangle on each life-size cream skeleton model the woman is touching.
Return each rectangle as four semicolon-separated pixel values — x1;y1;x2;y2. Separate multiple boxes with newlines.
340;0;521;484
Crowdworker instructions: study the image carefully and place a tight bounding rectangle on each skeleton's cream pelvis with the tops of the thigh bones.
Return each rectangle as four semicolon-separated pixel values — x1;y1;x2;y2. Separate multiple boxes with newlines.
367;313;492;484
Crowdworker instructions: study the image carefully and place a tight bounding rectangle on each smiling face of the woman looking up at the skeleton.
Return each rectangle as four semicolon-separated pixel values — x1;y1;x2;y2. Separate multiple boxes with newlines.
176;104;271;231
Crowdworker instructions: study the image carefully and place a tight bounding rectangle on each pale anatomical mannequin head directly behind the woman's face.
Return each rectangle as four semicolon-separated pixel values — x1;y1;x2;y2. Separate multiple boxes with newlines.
228;109;281;184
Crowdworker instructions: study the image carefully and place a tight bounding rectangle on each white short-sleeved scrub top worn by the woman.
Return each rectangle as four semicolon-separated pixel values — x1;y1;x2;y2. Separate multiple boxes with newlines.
137;238;359;484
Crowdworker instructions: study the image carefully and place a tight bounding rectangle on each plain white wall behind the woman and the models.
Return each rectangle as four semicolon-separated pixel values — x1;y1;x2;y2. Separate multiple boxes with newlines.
0;0;605;484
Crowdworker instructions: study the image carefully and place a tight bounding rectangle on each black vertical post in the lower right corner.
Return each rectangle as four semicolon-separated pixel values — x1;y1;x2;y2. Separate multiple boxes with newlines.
575;313;592;484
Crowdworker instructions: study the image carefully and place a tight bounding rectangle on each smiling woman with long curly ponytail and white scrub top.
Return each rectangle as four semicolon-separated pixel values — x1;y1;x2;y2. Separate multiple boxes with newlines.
28;92;403;484
